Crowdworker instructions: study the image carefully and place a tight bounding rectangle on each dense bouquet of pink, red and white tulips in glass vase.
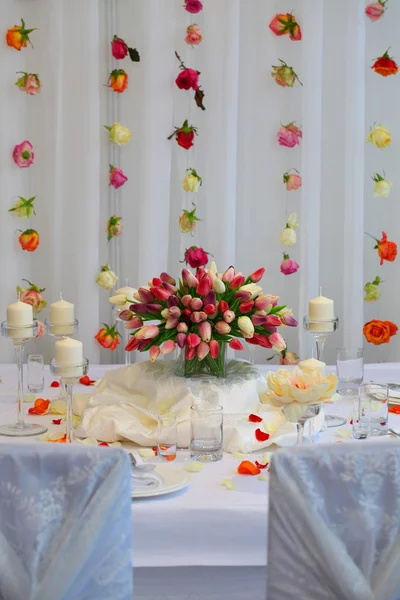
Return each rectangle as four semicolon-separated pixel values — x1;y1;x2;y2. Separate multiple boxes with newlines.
110;262;297;376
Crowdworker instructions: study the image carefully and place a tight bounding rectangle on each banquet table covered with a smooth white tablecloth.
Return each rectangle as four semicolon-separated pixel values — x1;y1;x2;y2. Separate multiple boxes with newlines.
0;363;400;600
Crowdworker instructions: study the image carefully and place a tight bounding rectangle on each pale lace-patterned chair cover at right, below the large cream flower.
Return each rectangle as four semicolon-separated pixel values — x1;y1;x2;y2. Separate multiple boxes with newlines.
267;441;400;600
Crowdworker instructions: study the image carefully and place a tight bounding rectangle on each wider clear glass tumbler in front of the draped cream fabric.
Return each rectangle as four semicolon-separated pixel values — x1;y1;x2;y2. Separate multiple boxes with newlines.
190;404;223;462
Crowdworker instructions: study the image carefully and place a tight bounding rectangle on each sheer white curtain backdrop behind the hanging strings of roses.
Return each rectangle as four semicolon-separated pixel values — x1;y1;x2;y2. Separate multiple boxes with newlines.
0;0;400;363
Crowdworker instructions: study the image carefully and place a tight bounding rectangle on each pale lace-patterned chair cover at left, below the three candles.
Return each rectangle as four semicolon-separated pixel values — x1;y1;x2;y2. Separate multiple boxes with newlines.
0;444;132;600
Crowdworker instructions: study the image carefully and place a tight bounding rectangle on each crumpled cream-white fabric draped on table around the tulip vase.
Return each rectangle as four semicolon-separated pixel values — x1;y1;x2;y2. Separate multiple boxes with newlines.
74;360;324;453
